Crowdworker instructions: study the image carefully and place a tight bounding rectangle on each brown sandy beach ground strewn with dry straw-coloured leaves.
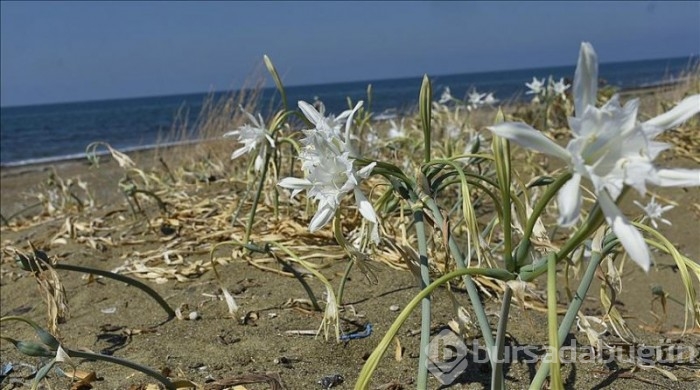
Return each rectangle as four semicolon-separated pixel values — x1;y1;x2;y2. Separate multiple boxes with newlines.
0;83;700;390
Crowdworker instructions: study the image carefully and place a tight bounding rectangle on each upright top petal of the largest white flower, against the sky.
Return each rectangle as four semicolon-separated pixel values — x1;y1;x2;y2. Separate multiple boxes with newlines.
574;42;598;117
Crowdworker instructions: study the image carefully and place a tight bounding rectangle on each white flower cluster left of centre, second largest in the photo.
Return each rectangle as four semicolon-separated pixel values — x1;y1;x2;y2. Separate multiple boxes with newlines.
278;101;379;242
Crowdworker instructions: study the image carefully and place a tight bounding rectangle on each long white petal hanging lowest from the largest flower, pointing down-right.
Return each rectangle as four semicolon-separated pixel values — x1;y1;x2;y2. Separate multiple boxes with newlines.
598;192;651;272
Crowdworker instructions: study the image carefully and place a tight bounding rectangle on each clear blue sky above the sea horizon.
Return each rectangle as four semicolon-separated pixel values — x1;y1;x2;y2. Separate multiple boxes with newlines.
0;1;700;106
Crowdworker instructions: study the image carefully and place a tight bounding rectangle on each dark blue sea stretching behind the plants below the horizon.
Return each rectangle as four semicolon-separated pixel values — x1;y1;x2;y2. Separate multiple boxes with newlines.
0;57;698;167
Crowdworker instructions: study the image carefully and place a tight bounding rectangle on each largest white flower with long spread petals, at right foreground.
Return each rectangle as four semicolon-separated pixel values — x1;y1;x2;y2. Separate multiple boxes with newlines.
489;42;700;270
